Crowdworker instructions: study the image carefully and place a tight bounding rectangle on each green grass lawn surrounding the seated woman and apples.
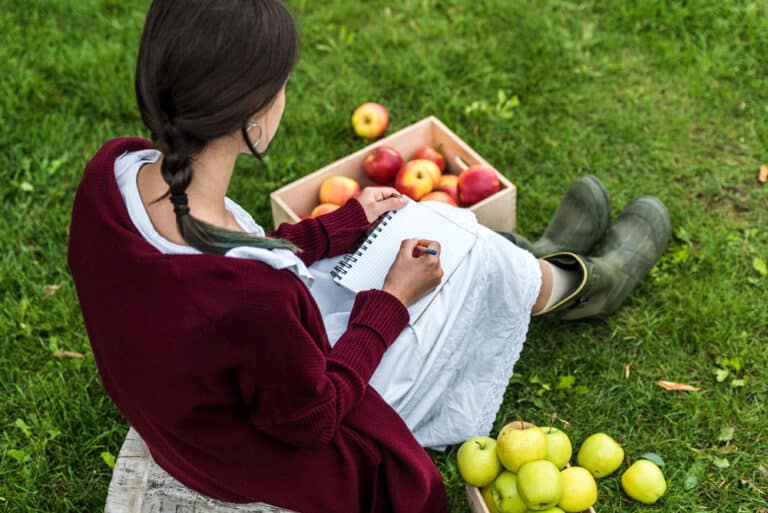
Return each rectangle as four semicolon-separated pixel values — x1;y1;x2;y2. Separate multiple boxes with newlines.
0;0;768;513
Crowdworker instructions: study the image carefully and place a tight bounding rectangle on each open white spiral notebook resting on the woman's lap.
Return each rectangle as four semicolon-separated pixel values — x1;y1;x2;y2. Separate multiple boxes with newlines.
331;201;477;324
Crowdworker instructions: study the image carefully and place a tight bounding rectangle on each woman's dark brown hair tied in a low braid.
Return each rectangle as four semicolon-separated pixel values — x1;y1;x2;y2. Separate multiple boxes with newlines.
135;0;298;253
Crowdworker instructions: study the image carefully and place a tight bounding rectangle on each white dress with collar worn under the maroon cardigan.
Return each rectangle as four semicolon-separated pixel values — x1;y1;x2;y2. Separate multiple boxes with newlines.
115;150;541;449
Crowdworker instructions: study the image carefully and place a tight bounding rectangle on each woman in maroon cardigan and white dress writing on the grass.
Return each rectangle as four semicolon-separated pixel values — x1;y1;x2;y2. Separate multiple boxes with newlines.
68;0;669;513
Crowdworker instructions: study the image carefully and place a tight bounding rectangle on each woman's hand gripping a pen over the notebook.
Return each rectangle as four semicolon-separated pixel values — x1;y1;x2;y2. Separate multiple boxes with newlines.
382;239;443;306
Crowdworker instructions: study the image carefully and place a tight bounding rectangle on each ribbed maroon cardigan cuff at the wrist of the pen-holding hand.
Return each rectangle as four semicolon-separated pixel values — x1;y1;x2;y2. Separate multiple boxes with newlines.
349;289;411;347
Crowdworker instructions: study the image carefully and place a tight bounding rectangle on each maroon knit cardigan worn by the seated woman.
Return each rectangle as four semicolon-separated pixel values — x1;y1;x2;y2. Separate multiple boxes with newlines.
68;139;447;513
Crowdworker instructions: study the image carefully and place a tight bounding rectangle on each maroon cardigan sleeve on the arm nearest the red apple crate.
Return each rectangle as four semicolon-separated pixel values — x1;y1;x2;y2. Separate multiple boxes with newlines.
269;199;371;266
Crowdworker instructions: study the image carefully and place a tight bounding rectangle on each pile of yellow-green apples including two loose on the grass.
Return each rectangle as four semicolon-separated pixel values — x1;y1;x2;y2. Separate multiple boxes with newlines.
457;422;667;513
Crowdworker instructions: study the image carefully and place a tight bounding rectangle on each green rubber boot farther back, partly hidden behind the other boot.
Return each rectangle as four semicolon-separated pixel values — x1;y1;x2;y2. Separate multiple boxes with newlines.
501;175;611;258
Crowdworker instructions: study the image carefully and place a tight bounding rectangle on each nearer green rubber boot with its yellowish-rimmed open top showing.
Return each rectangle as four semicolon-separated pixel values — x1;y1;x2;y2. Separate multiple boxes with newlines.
541;196;671;320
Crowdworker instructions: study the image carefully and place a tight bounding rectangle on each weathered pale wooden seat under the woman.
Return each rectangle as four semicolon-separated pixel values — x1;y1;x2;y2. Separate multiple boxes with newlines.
104;428;294;513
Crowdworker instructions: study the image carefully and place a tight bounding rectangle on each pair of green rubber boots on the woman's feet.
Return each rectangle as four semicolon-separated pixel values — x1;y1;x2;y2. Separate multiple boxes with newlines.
503;176;671;320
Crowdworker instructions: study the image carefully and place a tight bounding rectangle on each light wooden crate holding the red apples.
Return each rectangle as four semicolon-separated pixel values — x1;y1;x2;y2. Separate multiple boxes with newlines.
270;116;517;232
